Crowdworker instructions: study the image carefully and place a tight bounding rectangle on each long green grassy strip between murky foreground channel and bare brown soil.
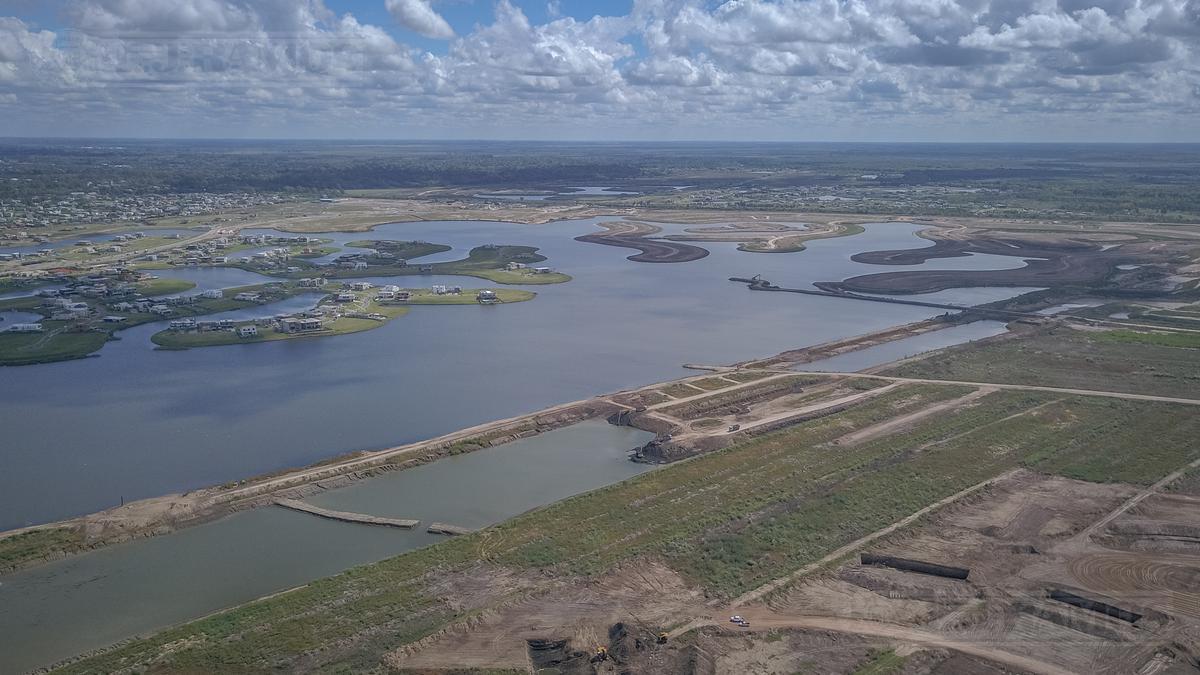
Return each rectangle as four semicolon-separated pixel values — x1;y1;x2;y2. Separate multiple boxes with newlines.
51;386;1200;673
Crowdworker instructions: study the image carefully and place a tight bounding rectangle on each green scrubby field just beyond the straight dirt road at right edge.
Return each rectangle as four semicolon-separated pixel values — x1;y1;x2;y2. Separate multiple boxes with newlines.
887;327;1200;398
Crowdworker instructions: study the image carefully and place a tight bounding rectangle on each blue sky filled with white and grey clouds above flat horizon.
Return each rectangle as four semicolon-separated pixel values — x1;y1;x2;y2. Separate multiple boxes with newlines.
0;0;1200;142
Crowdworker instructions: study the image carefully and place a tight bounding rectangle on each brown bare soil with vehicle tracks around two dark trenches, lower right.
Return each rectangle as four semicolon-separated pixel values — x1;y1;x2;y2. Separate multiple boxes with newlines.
719;472;1200;674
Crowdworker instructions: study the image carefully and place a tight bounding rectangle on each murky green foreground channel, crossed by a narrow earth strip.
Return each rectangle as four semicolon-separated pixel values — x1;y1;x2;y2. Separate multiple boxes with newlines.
0;420;652;673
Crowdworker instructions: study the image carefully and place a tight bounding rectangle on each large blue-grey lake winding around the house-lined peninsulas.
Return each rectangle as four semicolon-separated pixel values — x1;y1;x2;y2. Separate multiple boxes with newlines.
0;219;1041;528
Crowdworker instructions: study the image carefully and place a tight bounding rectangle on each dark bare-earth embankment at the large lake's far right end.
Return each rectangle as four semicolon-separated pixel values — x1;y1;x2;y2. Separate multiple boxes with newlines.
817;237;1186;293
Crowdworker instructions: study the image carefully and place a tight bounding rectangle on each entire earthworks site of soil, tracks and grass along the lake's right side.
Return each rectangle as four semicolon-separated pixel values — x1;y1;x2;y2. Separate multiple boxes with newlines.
14;205;1200;675
